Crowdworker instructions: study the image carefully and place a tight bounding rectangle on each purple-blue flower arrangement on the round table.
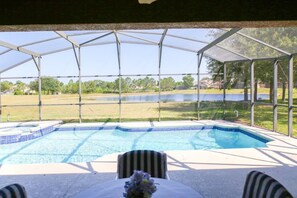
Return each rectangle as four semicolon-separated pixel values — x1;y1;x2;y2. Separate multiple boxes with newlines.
123;170;157;198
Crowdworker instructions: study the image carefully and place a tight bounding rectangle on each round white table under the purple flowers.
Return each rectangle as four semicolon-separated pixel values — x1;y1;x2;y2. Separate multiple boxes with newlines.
75;178;203;198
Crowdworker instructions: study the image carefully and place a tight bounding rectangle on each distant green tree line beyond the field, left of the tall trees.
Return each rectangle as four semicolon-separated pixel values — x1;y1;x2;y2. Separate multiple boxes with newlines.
1;75;194;95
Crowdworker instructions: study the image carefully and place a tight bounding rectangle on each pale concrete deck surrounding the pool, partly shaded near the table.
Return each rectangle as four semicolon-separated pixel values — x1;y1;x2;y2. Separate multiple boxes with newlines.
0;120;297;198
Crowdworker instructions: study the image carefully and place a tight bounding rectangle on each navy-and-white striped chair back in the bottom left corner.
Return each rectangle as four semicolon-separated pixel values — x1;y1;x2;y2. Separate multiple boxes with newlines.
0;184;27;198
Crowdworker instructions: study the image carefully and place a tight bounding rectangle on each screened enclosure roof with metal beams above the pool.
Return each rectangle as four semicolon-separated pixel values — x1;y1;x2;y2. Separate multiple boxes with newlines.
0;27;297;73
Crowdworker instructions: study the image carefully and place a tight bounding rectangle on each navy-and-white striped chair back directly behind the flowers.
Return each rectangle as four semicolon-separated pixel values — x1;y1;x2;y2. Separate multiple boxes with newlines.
118;150;167;179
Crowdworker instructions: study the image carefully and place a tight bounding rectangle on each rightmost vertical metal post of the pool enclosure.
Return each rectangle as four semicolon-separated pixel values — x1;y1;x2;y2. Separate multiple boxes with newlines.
288;55;293;137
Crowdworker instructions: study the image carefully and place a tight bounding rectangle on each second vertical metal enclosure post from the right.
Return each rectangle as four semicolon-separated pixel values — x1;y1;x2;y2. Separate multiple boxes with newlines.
273;59;278;131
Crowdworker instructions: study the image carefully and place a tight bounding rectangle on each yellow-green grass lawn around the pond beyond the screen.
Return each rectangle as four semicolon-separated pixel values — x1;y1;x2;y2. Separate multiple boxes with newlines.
2;88;297;137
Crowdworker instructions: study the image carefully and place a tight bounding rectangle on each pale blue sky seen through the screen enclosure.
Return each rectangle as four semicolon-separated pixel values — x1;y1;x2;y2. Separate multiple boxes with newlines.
0;29;217;83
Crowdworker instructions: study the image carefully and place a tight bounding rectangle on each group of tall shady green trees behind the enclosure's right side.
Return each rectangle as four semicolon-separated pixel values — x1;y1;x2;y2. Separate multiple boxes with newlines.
208;28;297;102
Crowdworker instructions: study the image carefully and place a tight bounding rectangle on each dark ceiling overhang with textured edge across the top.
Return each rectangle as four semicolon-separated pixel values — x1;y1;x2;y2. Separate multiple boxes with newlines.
0;0;297;31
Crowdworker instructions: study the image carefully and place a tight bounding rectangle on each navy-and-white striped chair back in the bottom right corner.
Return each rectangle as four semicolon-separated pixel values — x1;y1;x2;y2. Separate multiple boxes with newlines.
242;171;293;198
